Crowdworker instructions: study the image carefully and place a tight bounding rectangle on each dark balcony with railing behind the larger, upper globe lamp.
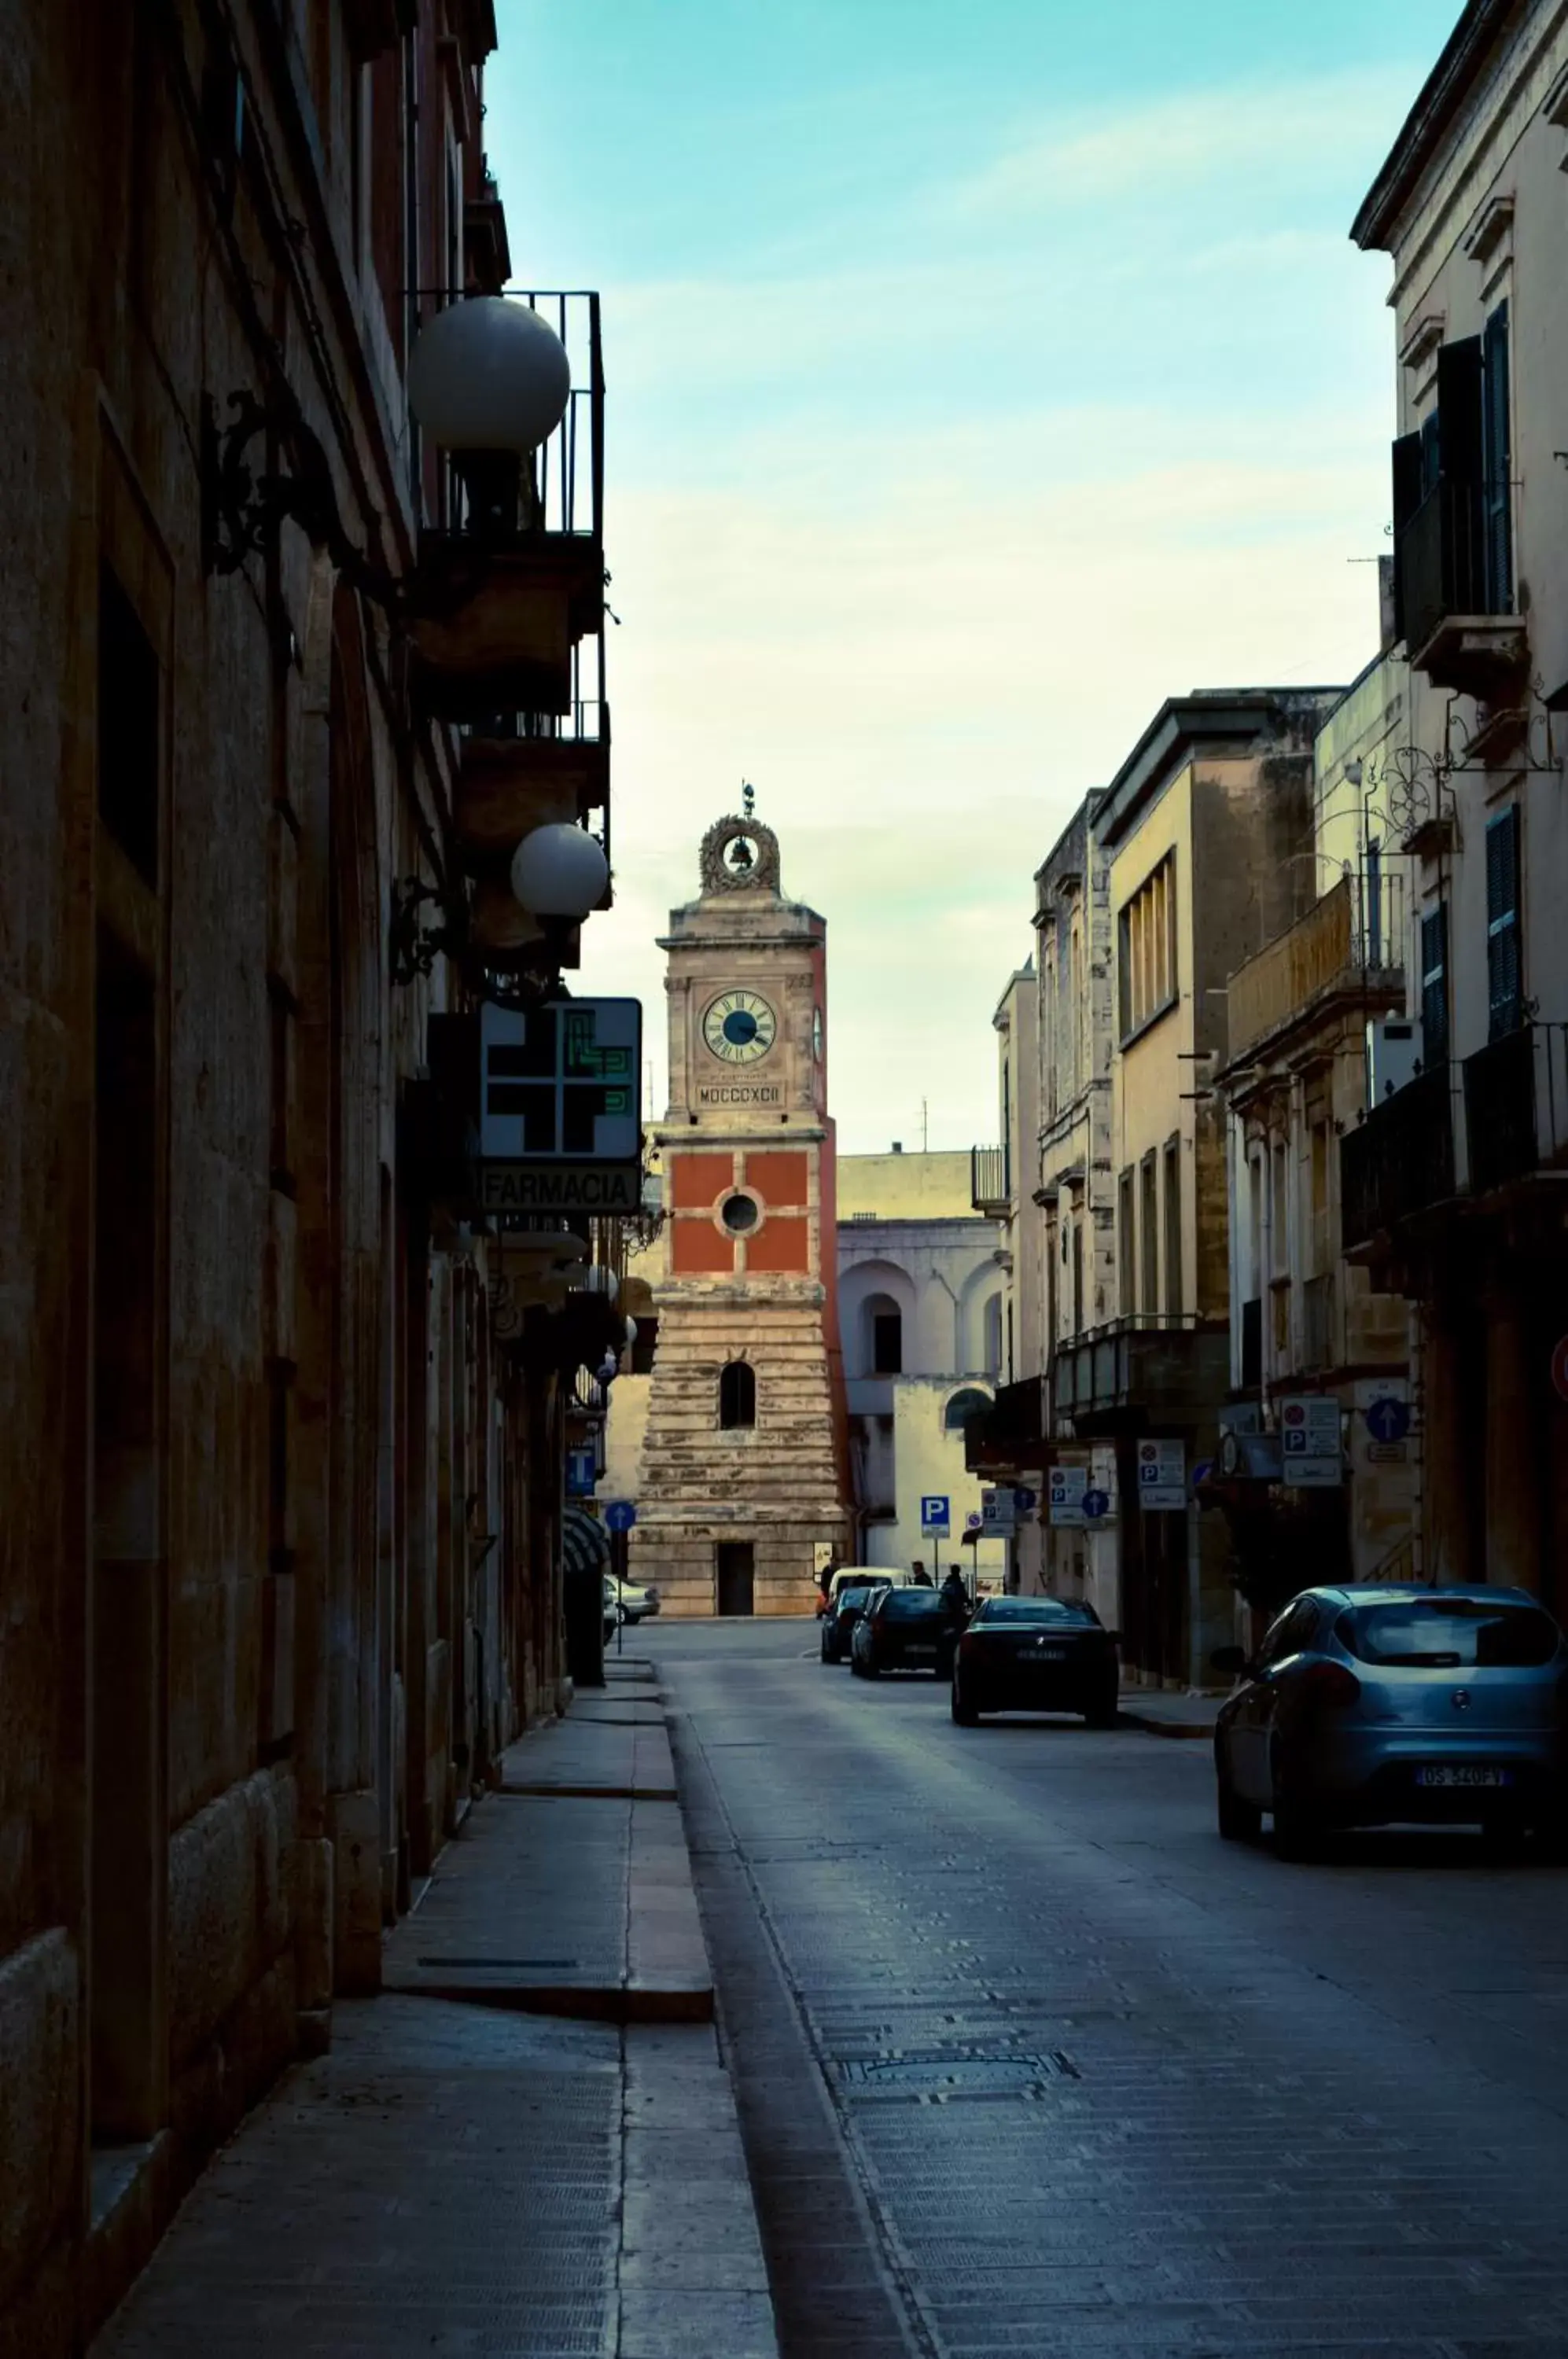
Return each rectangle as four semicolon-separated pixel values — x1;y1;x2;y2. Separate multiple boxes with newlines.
408;293;604;722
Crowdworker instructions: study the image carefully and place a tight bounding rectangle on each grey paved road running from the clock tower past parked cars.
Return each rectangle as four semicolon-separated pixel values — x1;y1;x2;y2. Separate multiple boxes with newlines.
637;1623;1568;2359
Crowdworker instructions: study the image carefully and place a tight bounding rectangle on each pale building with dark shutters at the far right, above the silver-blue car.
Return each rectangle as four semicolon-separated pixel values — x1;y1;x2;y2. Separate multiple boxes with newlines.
1339;0;1568;1614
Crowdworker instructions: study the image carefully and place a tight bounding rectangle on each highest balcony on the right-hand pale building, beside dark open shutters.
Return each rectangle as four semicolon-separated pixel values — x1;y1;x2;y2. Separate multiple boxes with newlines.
1398;481;1530;703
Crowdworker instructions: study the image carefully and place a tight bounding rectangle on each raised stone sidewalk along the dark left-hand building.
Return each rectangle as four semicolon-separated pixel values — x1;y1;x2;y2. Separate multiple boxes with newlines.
92;1658;778;2359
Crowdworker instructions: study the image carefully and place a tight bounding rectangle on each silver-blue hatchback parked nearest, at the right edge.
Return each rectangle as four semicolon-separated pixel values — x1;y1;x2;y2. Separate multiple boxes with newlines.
1214;1585;1568;1859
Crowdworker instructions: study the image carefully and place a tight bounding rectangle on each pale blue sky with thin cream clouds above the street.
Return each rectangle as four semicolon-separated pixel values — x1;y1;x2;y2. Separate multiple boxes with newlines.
486;0;1459;1154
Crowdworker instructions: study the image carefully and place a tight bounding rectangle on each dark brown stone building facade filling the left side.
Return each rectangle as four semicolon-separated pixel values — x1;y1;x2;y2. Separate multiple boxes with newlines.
0;0;598;2359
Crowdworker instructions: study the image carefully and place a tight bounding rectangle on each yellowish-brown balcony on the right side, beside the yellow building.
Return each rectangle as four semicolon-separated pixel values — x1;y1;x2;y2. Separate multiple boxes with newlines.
1226;870;1405;1064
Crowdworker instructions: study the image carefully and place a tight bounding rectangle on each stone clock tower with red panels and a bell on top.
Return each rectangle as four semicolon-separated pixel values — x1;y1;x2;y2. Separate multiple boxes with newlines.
632;816;851;1614
